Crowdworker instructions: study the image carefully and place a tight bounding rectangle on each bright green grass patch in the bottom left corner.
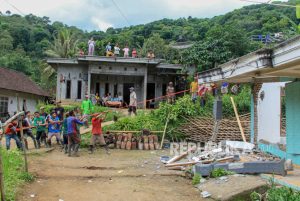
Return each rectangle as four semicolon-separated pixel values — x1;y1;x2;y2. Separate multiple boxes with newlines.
1;149;34;201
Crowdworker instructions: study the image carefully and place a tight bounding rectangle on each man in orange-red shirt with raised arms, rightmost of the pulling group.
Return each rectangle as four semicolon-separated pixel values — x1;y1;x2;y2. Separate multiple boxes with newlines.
90;112;109;154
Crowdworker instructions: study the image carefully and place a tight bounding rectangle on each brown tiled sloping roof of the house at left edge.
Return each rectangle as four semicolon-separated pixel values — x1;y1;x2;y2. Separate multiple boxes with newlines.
0;67;48;96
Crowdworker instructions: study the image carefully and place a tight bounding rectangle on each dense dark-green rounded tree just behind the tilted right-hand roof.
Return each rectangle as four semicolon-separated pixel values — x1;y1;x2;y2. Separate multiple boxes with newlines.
182;25;253;71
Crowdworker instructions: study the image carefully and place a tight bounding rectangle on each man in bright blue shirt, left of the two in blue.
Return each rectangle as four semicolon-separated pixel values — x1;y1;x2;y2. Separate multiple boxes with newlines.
47;112;62;146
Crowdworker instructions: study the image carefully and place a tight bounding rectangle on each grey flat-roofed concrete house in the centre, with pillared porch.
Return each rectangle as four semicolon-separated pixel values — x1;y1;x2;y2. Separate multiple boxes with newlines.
47;56;183;107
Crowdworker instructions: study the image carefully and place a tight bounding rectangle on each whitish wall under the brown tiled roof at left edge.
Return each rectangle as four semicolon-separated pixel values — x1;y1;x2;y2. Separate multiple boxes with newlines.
0;89;44;118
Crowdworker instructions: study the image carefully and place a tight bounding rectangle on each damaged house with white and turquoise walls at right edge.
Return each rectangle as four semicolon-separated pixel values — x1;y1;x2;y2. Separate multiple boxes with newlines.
199;36;300;165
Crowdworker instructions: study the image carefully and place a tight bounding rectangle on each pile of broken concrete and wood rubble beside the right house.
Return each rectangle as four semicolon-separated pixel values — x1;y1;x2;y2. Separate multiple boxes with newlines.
161;141;292;176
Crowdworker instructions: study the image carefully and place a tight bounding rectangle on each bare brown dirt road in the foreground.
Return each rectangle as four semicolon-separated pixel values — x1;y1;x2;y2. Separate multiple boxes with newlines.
17;149;202;201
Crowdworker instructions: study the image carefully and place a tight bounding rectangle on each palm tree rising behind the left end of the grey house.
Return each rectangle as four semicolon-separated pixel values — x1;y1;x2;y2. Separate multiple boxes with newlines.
45;28;78;58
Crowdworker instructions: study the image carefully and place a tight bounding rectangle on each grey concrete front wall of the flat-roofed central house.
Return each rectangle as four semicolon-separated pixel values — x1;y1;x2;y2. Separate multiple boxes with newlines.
56;63;174;102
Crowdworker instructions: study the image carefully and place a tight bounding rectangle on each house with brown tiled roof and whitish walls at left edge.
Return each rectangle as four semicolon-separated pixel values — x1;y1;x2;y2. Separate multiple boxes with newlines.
0;68;48;119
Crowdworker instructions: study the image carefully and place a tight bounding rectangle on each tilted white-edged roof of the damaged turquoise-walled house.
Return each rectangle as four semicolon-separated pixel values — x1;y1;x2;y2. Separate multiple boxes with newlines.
198;36;300;83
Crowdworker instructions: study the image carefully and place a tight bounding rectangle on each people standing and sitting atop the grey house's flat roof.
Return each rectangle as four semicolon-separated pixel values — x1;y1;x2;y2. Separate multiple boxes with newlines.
85;37;155;59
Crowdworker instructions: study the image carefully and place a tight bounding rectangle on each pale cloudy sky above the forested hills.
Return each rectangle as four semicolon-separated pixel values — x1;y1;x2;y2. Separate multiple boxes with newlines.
0;0;266;31
